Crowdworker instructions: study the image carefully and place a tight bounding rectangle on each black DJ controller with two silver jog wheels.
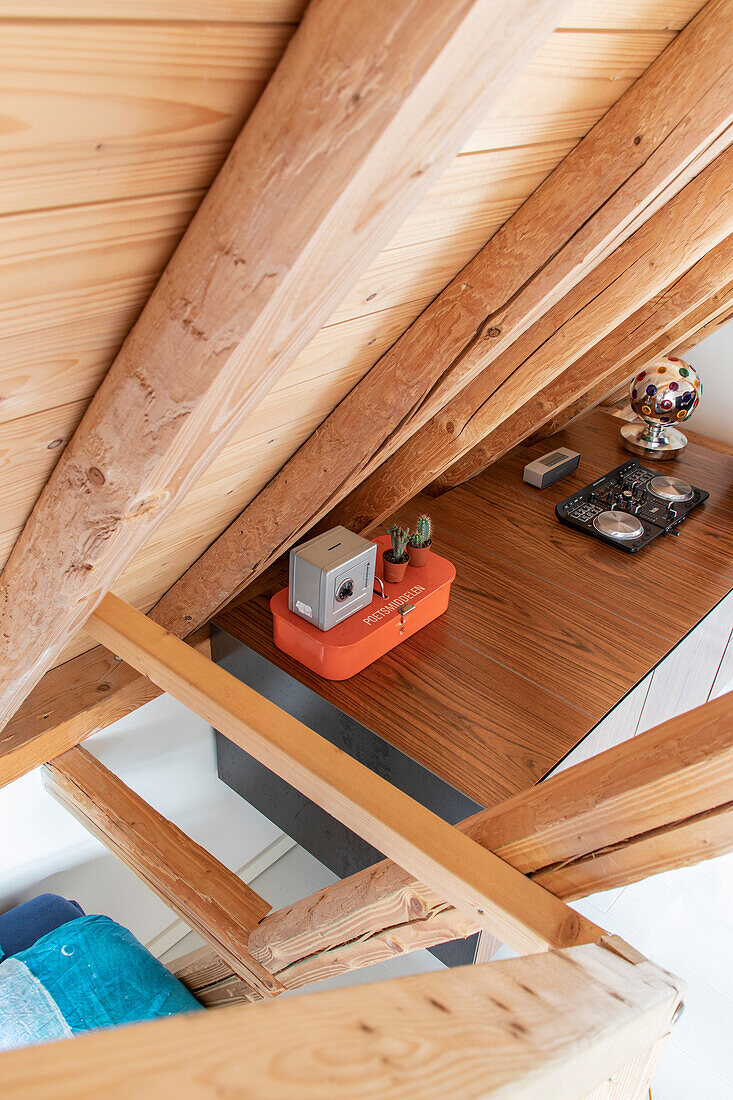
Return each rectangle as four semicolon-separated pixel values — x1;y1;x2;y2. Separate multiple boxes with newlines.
555;460;710;553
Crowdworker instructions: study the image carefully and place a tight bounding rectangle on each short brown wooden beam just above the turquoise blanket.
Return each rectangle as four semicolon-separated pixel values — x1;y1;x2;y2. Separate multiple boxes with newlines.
43;748;279;997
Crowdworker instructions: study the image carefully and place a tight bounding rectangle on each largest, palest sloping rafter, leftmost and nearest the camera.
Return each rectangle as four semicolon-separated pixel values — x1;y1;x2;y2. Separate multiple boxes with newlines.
0;0;564;727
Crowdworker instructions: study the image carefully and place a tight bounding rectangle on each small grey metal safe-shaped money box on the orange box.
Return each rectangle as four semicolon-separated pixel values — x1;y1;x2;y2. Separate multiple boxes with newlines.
287;527;376;630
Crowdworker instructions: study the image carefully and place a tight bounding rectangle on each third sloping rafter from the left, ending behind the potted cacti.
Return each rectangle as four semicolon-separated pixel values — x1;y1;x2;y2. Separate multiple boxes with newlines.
326;149;733;531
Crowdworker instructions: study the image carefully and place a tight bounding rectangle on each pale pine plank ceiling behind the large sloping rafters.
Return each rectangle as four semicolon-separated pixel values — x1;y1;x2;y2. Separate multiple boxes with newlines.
0;0;702;661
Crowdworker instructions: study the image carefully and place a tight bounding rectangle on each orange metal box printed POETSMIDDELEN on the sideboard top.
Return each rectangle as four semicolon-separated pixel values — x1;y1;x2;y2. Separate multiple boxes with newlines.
270;535;456;680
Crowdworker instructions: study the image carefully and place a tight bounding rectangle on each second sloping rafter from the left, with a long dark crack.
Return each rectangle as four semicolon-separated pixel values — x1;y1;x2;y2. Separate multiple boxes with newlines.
152;0;733;633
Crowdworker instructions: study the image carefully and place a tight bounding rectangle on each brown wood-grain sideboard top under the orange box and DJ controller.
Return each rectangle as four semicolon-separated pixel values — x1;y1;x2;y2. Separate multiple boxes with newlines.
217;410;733;806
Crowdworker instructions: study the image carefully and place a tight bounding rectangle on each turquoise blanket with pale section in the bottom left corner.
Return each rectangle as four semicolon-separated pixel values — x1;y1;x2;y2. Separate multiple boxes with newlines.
0;916;200;1051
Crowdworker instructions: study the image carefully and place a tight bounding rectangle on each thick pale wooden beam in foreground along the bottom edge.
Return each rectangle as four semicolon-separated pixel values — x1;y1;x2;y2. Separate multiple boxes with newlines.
3;936;685;1100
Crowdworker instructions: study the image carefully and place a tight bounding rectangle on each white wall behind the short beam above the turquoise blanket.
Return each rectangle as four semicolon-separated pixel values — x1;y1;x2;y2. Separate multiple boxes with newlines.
0;695;292;949
